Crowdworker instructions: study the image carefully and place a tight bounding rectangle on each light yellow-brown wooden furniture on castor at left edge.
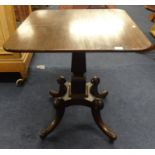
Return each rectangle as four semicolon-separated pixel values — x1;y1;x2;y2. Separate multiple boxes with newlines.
0;5;32;85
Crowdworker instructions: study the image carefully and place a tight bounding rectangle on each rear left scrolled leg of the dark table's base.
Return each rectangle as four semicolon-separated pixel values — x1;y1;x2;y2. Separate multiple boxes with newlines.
49;76;67;98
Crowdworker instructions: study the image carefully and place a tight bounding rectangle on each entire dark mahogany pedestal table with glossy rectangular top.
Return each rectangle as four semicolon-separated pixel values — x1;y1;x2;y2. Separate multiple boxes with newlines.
4;9;152;140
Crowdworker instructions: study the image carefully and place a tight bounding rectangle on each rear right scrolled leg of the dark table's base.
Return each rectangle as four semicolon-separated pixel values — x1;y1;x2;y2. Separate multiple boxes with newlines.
90;76;108;98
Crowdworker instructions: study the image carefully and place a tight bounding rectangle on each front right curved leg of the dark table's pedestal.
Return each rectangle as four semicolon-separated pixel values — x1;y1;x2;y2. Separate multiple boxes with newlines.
92;103;117;141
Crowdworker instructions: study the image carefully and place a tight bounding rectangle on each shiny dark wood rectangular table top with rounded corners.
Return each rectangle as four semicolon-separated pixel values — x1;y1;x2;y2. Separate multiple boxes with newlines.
4;9;151;52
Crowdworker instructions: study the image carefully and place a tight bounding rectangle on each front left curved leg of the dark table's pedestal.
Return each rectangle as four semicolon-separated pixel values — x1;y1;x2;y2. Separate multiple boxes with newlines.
40;99;65;139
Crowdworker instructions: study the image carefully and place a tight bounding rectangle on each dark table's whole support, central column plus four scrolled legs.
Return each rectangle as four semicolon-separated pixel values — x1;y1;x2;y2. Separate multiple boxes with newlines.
40;53;117;141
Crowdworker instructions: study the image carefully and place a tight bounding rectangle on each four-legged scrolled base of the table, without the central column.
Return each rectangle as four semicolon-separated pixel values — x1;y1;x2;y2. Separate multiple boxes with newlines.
40;76;117;141
